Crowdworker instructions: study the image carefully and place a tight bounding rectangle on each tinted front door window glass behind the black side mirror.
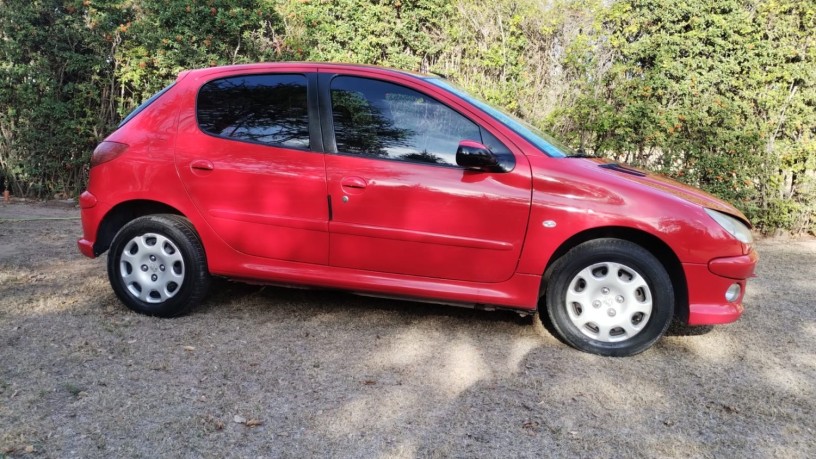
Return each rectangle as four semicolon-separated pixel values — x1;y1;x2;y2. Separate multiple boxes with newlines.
331;77;482;166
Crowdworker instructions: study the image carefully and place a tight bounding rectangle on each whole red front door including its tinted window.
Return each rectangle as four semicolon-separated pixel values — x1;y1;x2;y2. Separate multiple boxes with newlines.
321;75;531;282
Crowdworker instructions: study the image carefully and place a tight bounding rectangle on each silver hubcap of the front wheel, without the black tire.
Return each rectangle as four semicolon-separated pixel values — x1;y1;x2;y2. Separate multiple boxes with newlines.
566;262;652;343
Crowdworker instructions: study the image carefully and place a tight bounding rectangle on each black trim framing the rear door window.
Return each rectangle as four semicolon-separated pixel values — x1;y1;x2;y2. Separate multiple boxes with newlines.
194;71;324;154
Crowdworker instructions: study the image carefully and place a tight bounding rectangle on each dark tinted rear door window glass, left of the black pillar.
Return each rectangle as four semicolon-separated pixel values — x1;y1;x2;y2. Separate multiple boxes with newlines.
197;75;309;148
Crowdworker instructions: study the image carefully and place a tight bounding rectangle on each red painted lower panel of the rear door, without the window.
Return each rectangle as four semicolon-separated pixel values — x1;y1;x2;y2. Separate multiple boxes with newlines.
176;116;329;264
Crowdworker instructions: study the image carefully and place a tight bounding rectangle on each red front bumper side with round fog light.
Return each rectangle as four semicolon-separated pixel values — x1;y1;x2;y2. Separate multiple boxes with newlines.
683;251;759;325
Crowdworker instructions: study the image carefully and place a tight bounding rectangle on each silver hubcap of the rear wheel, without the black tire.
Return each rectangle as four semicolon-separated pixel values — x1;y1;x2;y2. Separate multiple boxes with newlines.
119;233;184;303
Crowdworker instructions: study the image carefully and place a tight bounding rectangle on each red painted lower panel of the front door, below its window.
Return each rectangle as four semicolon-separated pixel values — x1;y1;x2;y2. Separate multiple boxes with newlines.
326;155;530;282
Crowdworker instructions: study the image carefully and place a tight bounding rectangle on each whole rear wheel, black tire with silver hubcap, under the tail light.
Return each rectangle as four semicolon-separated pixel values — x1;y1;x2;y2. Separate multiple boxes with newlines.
108;214;210;317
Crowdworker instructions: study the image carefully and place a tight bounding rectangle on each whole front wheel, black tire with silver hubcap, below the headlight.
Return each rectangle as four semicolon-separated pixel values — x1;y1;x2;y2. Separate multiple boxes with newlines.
537;238;675;357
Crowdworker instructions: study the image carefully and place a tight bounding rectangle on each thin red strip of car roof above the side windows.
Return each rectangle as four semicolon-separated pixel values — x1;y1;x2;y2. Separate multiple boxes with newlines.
177;61;434;80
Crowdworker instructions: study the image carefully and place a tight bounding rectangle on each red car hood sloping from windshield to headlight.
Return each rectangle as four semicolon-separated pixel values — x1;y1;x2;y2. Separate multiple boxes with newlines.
589;158;750;226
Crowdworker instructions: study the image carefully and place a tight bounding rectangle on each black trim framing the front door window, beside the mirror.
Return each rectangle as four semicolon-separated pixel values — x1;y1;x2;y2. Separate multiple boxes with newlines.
317;73;518;174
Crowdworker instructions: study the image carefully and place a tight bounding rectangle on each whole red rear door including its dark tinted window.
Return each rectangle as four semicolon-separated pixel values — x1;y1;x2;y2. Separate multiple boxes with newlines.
176;68;329;264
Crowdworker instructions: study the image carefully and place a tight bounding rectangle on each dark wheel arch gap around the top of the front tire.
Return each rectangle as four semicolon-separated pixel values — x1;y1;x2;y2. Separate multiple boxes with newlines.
541;226;689;323
